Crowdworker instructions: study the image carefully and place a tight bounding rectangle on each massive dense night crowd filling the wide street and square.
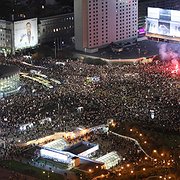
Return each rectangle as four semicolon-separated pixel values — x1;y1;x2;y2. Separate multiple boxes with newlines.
0;57;180;159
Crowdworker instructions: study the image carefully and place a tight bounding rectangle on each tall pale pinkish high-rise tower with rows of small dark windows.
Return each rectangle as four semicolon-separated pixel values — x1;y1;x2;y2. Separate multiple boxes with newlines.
74;0;138;52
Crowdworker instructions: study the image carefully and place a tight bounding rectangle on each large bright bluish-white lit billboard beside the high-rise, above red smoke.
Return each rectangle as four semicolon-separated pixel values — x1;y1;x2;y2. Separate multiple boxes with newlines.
146;7;180;38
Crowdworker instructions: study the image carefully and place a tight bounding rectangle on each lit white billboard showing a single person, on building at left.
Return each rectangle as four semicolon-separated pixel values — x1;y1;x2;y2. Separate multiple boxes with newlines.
14;18;38;50
